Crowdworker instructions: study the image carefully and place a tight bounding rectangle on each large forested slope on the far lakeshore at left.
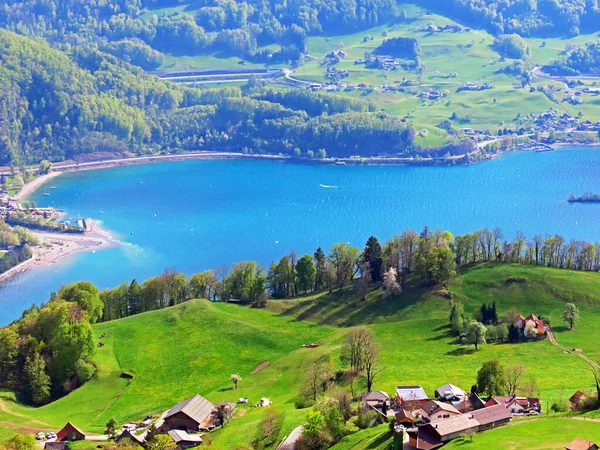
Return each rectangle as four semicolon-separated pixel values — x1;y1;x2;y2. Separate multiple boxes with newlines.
0;30;419;165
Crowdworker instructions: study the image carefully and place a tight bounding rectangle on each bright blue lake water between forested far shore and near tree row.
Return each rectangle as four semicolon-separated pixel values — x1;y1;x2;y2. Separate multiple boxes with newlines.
0;147;600;325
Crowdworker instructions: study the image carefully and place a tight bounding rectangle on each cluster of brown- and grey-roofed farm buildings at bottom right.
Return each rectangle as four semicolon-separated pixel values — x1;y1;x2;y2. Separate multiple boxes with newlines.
362;384;542;450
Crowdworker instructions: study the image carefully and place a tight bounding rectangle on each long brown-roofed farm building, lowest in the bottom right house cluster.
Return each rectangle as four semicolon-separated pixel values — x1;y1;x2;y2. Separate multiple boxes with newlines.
409;405;511;450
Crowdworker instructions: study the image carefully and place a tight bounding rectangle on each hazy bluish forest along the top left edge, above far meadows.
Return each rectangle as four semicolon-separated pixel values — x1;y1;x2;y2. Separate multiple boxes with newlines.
0;0;394;61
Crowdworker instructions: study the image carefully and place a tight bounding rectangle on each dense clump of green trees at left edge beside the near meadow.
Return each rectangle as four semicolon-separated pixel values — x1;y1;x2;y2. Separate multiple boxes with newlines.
0;282;103;405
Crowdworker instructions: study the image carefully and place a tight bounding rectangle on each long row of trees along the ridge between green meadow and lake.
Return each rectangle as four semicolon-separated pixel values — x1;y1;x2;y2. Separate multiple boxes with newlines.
71;227;600;326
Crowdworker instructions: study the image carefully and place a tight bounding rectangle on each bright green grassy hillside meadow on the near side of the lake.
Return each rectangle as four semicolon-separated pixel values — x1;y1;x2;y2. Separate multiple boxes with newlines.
0;265;600;449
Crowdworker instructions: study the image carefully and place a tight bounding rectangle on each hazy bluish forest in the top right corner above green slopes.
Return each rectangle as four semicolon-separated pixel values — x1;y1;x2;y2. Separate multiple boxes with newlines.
410;0;600;36
